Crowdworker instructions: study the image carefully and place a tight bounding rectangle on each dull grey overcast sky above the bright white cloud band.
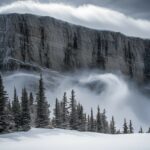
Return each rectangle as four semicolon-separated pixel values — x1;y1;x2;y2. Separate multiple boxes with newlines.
0;0;150;20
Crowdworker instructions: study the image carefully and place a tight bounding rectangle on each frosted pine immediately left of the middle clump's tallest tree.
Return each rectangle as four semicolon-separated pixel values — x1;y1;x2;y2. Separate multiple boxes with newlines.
62;92;69;129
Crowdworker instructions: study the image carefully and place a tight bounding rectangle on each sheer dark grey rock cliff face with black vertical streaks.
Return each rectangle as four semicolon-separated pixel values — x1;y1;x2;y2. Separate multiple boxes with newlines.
0;14;150;82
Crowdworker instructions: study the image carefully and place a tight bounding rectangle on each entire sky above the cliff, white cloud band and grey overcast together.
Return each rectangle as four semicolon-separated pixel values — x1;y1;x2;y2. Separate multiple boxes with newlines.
0;0;150;38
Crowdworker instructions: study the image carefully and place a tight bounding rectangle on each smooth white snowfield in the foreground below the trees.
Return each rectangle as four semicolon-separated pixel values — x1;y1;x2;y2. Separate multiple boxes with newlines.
0;128;150;150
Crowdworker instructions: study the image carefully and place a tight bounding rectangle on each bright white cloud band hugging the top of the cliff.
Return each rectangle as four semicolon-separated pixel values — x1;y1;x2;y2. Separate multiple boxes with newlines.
0;1;150;38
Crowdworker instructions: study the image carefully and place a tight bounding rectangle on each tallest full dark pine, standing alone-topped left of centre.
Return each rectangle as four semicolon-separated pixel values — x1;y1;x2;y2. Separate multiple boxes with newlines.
36;75;50;128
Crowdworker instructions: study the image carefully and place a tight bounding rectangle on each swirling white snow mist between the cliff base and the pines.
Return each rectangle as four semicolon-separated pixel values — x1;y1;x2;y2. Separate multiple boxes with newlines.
4;71;150;131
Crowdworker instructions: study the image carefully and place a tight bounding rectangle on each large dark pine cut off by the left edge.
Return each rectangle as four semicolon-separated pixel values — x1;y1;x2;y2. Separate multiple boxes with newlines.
0;75;14;133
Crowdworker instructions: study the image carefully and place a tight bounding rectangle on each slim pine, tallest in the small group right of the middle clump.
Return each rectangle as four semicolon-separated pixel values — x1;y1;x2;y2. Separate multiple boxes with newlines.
96;106;103;133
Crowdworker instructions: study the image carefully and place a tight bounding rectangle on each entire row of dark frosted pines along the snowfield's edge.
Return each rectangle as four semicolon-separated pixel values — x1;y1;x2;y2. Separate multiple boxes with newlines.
0;75;150;134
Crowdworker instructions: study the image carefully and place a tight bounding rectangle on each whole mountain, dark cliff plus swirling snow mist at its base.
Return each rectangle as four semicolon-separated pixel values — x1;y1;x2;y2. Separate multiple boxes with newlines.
0;14;150;131
